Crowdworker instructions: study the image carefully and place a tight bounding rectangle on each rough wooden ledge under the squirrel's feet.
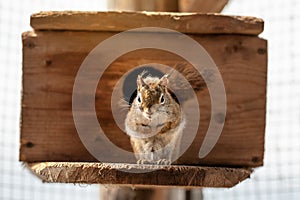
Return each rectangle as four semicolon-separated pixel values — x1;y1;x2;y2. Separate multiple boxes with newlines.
28;162;252;188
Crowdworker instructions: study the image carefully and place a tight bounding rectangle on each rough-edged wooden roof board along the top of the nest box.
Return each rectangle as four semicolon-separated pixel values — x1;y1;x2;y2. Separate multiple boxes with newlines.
31;11;264;35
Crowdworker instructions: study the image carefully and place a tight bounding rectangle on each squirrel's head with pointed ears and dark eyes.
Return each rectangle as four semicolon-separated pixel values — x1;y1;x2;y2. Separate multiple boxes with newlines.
134;75;172;119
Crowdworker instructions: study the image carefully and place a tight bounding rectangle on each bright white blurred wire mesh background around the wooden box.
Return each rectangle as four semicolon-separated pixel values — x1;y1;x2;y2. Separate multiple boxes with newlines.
0;0;300;200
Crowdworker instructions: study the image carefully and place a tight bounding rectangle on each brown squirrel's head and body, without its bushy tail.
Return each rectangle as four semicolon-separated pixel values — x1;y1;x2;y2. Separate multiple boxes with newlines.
125;73;185;165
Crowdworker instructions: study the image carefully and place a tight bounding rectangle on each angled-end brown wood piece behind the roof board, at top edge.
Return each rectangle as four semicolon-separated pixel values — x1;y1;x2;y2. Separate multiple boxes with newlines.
178;0;228;13
